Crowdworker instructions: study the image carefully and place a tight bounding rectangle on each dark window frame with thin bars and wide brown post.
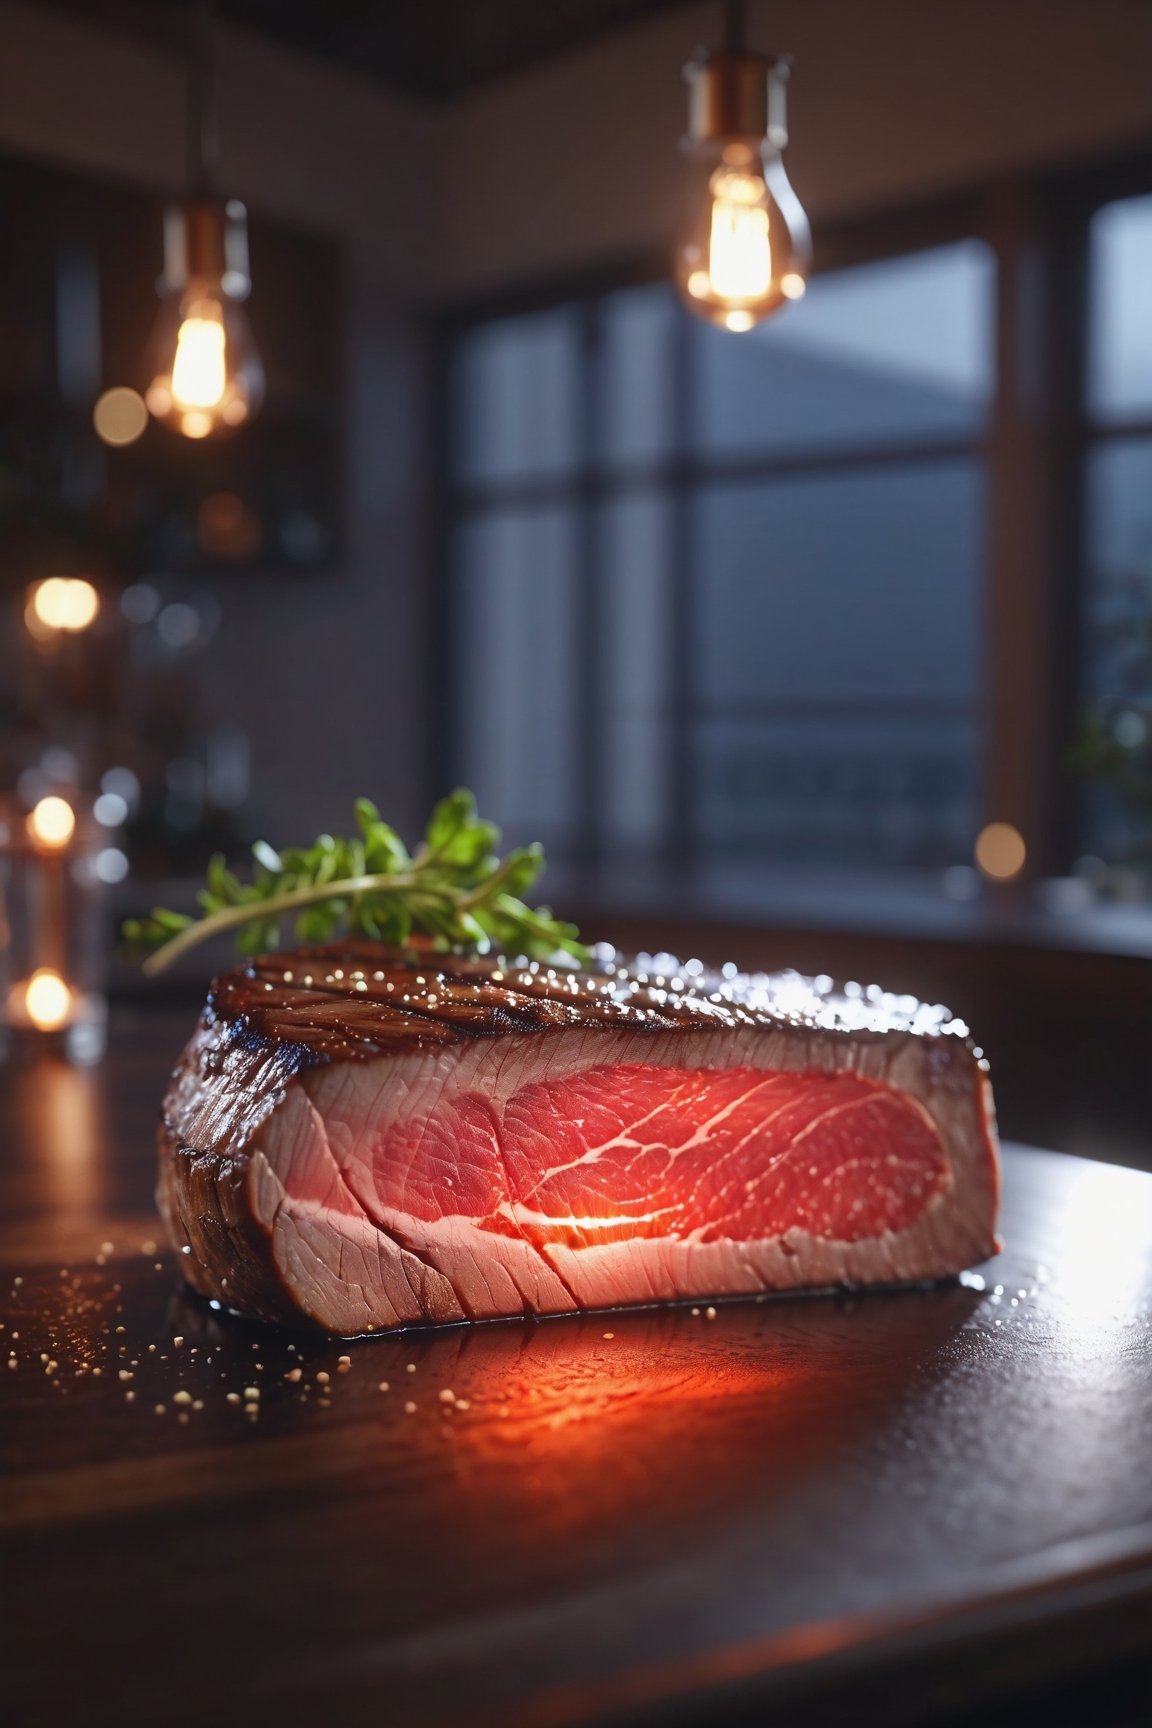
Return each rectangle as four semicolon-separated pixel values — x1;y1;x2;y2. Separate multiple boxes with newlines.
434;149;1152;878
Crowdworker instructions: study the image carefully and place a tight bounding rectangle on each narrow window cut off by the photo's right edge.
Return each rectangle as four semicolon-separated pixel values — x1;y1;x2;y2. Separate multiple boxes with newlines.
1081;195;1152;862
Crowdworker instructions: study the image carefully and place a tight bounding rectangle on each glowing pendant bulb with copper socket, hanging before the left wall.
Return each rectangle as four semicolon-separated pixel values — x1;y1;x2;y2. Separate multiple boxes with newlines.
145;199;264;439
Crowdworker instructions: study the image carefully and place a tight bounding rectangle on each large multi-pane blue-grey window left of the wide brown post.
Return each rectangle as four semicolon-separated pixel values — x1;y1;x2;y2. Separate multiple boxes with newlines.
449;238;995;867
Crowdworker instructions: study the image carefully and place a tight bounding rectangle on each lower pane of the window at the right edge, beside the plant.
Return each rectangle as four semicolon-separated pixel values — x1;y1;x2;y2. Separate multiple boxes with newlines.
1079;439;1152;867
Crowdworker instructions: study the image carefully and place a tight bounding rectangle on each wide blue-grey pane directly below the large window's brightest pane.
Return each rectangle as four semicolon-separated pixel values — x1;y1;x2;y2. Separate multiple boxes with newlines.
696;461;983;702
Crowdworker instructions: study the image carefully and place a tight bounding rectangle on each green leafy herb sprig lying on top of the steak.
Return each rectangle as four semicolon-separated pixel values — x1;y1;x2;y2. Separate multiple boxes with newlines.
123;788;589;973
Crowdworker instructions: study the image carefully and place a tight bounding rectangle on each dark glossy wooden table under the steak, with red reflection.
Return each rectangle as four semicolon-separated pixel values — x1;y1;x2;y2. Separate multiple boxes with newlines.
0;1011;1152;1725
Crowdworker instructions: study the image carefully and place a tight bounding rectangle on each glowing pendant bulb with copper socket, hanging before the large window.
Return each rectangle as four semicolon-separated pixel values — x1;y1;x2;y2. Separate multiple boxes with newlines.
675;47;812;330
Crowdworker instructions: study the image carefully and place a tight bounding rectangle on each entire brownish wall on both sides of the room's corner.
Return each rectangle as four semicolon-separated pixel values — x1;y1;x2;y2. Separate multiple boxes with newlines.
0;0;1152;833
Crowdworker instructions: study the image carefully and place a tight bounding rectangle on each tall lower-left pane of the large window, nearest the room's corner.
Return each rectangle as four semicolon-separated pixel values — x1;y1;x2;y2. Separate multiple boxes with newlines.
453;510;579;852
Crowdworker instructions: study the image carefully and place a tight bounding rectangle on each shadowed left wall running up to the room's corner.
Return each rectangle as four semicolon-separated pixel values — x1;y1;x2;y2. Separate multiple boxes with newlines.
0;0;432;838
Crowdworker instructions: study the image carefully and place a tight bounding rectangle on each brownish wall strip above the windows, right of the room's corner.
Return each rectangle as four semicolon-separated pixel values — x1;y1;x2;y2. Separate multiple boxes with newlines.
439;0;1152;297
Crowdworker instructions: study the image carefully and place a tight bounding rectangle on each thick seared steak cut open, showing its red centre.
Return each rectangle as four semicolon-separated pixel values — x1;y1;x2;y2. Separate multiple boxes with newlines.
159;943;998;1336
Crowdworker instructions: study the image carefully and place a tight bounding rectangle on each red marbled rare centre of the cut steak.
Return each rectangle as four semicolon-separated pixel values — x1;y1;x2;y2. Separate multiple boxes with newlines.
363;1064;948;1246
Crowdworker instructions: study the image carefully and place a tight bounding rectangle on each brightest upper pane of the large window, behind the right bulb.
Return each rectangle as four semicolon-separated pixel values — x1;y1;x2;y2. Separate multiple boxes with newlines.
693;240;995;454
